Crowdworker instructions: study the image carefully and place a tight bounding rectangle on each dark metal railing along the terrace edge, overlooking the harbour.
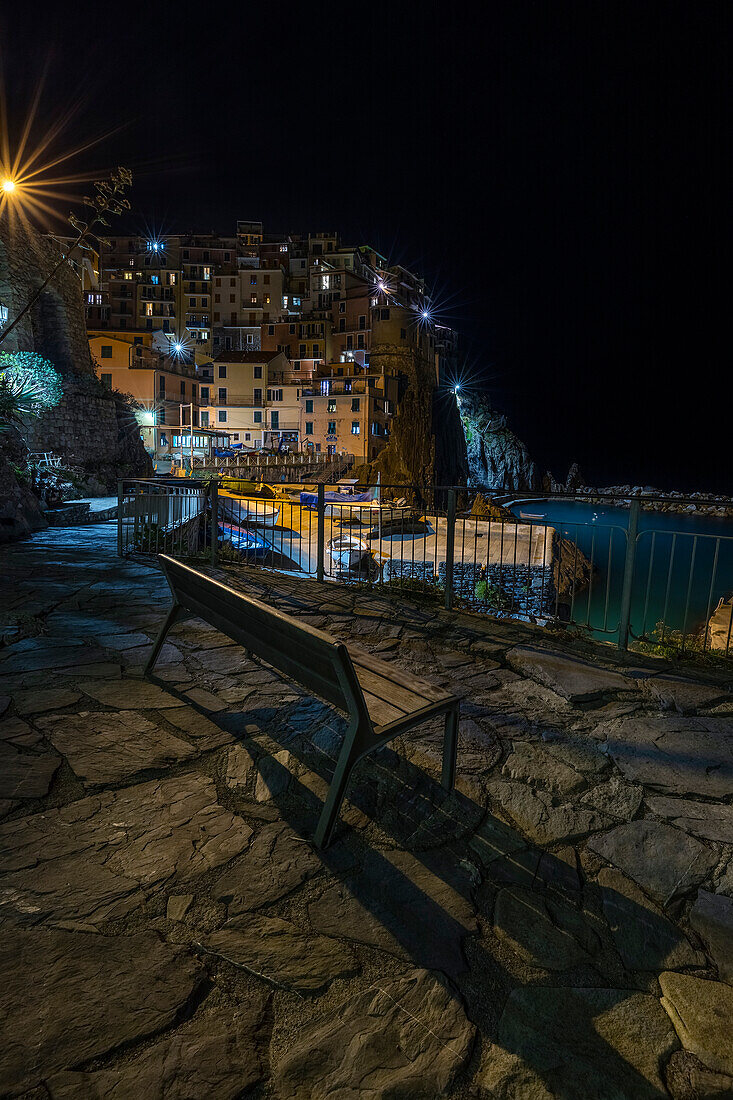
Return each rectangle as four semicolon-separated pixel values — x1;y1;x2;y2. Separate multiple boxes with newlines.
118;481;733;659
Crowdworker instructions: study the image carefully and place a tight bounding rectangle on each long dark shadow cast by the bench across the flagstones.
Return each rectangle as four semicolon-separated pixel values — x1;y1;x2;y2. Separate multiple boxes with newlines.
183;696;681;1100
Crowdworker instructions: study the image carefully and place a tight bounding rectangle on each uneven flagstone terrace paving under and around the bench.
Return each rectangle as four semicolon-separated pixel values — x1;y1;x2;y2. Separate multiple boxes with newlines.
0;524;733;1100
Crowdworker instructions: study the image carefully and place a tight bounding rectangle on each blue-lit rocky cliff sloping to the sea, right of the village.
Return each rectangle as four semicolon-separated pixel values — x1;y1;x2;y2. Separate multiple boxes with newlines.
457;393;543;492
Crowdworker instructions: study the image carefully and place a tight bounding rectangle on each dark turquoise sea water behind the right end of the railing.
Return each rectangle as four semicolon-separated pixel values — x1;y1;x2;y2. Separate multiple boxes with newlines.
512;501;733;638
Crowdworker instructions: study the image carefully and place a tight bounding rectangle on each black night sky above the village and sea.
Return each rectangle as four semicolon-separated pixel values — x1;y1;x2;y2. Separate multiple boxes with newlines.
7;0;733;493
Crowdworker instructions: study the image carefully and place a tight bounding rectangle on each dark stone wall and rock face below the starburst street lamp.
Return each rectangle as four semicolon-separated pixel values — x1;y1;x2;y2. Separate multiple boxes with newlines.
0;219;151;510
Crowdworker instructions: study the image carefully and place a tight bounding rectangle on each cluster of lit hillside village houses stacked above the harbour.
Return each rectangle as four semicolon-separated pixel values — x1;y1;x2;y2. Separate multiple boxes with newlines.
81;220;456;462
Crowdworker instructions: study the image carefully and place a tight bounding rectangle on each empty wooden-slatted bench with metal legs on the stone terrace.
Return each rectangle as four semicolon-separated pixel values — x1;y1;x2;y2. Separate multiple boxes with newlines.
145;554;459;847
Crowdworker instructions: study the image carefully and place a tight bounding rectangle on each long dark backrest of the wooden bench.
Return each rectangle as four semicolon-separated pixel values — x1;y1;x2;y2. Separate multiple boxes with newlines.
158;554;361;712
